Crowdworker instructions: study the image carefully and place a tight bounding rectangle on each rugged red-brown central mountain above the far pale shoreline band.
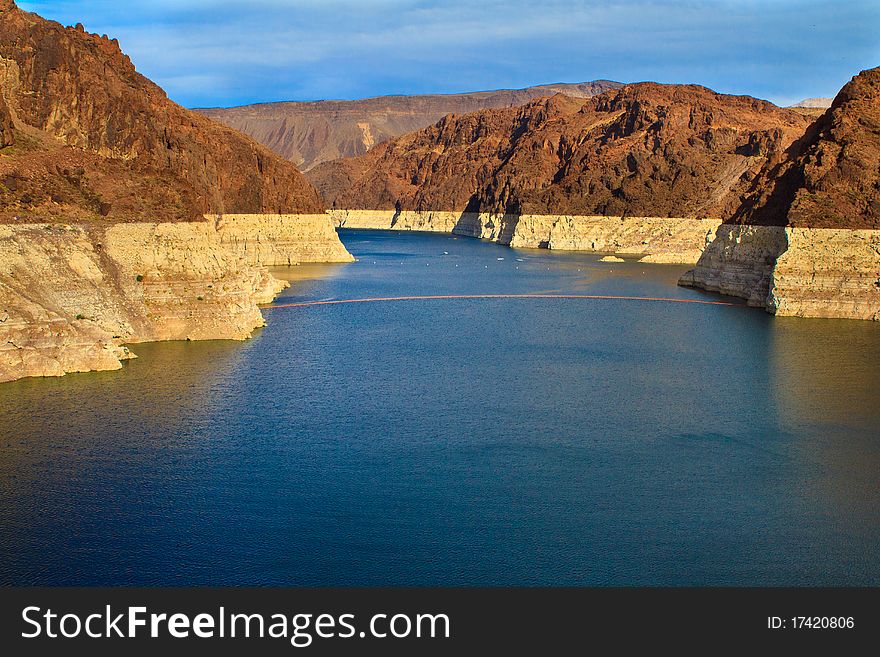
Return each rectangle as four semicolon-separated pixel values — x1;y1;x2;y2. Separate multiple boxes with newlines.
308;83;809;217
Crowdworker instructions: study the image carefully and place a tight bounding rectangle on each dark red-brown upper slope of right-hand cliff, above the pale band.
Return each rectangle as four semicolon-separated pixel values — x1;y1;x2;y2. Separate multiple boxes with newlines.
733;68;880;228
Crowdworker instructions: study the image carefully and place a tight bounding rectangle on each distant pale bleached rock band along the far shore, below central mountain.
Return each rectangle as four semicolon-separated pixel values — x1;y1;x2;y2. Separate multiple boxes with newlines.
330;210;721;264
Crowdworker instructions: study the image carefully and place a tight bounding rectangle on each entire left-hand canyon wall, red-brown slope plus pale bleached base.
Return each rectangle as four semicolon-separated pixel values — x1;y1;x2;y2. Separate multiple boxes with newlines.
0;0;360;381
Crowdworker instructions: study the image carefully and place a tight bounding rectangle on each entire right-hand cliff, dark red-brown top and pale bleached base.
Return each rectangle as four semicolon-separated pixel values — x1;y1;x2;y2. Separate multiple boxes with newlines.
681;69;880;320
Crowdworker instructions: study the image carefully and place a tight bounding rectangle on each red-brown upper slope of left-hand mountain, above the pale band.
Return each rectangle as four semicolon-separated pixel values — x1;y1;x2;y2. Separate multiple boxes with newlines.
0;0;323;220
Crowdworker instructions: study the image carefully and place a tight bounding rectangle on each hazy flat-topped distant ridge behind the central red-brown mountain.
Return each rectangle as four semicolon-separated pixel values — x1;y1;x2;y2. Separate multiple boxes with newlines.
197;80;621;171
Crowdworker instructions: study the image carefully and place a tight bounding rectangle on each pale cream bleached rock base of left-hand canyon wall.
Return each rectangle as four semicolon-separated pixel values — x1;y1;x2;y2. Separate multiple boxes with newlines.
0;215;351;381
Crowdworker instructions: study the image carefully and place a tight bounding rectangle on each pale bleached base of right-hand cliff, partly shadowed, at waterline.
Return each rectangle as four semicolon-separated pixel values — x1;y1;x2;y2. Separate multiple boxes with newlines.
680;225;880;321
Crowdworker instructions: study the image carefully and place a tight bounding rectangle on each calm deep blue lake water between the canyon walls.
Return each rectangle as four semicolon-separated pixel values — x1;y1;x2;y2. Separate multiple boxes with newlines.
0;231;880;585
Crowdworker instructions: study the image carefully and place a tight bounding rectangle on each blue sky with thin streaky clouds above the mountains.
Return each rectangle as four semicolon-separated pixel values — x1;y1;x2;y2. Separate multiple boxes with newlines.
19;0;880;107
